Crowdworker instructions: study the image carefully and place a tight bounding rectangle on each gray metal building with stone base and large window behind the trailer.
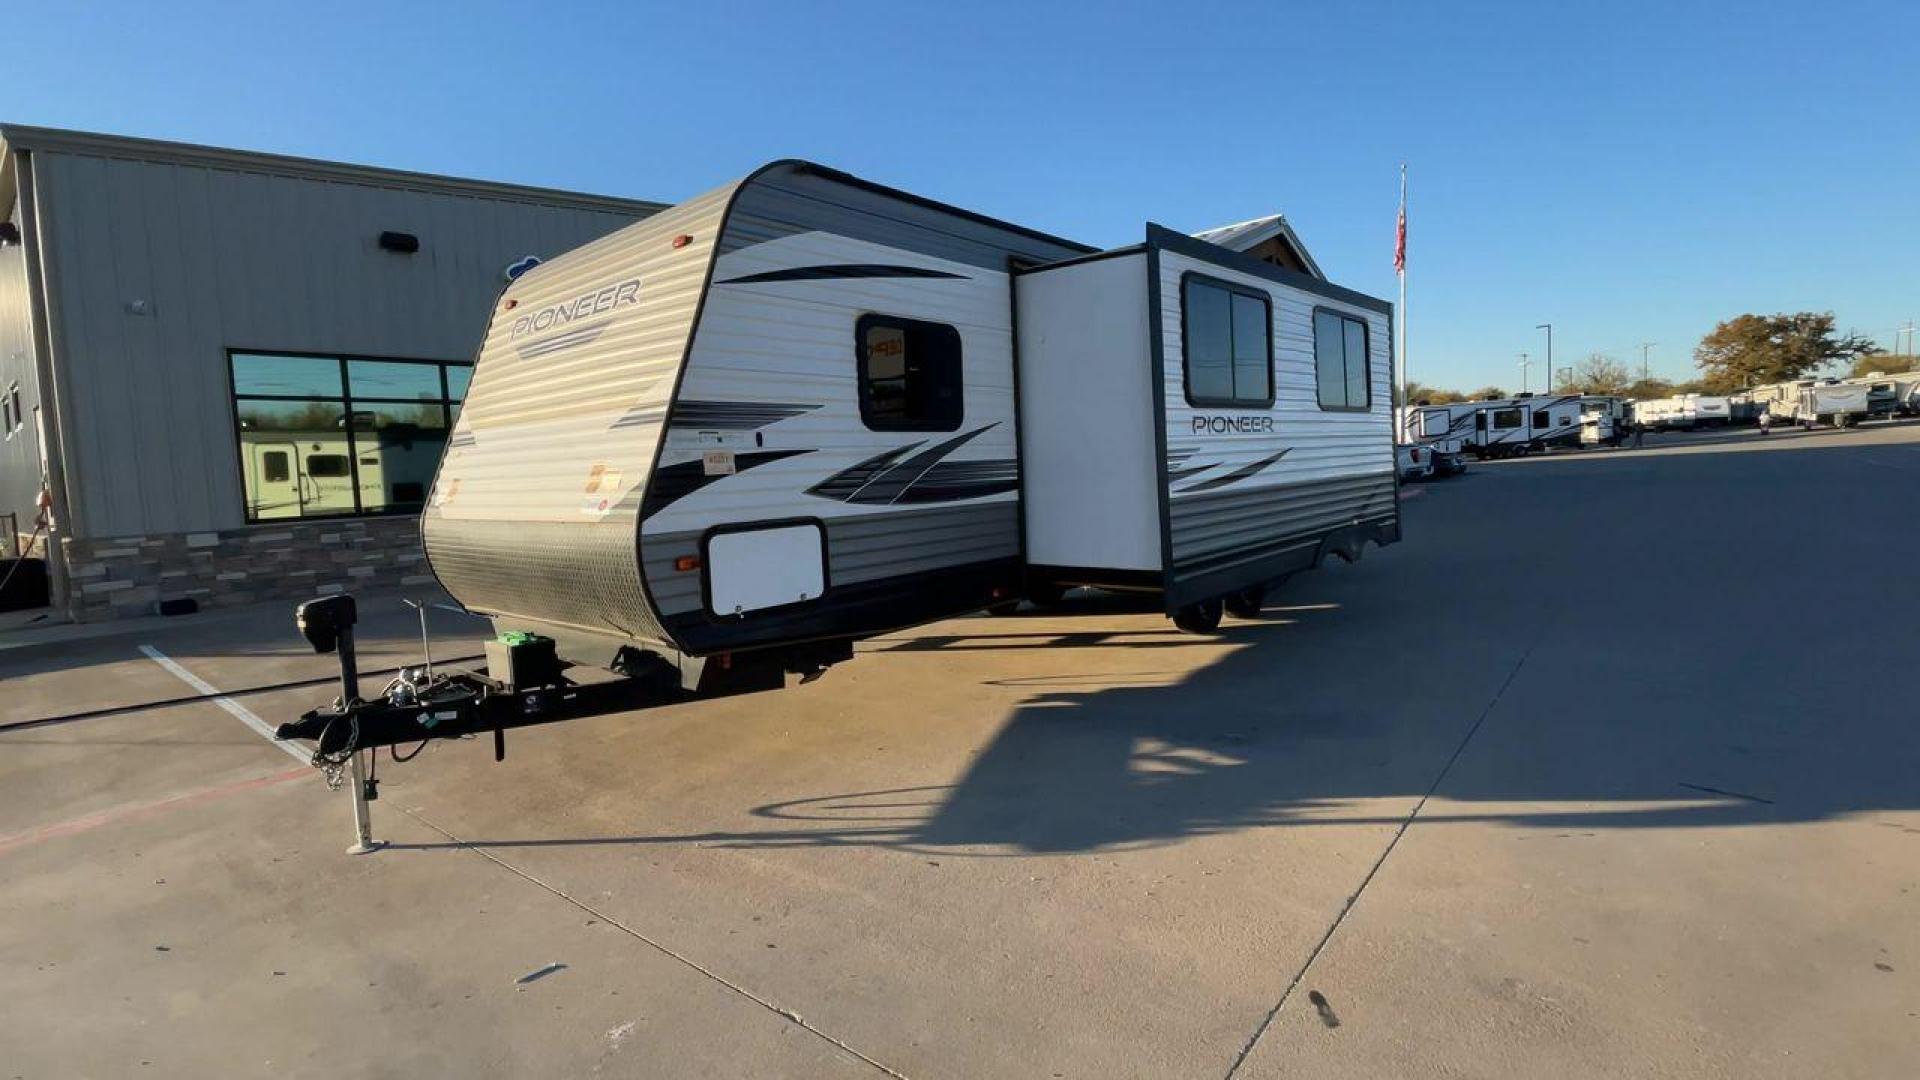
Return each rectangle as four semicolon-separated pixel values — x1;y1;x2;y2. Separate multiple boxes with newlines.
0;125;659;621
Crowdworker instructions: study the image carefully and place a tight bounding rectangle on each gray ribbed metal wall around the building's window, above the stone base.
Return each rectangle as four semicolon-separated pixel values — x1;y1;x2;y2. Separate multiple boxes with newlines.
28;150;641;536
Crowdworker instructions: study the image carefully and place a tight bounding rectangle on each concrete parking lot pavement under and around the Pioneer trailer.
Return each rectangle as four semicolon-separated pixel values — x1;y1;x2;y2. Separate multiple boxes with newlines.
0;417;1920;1078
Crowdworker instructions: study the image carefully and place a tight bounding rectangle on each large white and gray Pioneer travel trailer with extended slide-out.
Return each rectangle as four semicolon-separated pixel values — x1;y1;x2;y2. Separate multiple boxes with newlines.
422;161;1400;684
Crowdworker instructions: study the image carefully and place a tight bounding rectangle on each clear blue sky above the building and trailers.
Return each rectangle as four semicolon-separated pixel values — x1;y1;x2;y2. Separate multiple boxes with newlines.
0;0;1920;388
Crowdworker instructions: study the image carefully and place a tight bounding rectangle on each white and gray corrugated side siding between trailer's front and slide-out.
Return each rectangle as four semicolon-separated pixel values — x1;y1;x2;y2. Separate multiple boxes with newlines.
641;163;1079;615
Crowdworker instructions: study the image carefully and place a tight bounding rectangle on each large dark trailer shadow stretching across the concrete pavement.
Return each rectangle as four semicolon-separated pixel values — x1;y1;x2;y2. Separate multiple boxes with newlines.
382;422;1920;855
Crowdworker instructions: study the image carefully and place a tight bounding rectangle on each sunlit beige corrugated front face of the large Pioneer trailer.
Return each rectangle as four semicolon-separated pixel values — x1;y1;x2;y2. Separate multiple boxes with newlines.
424;186;732;640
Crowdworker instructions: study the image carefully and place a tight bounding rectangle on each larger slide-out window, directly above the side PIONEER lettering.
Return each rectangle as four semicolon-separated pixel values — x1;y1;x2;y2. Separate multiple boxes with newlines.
1181;273;1273;409
